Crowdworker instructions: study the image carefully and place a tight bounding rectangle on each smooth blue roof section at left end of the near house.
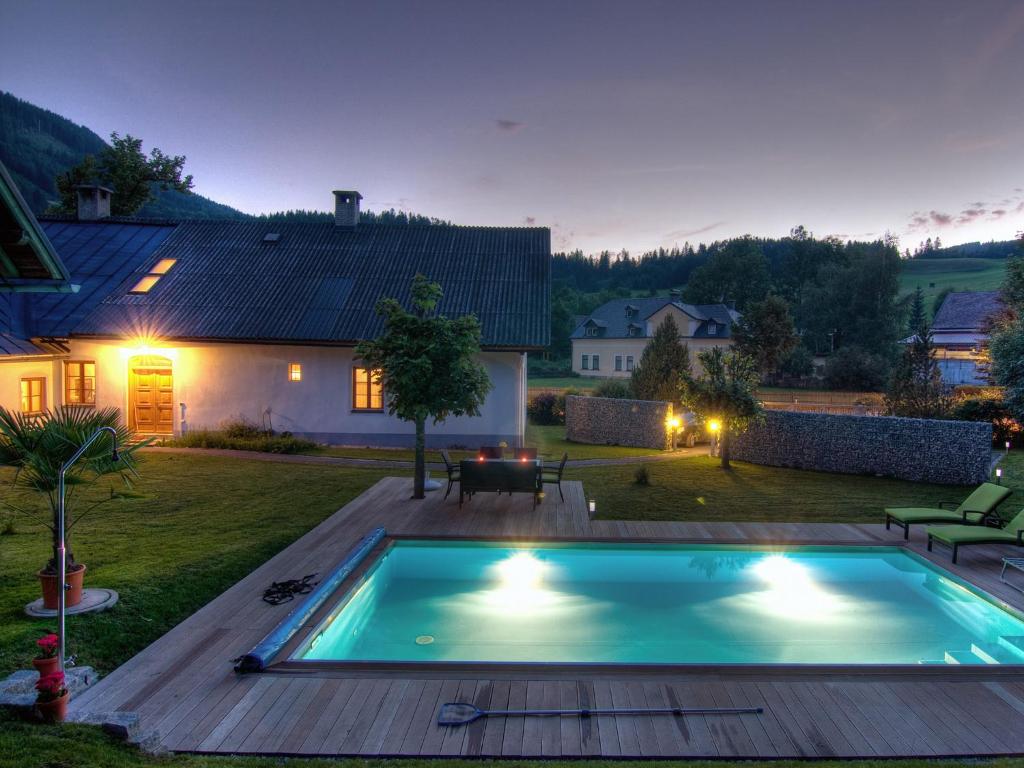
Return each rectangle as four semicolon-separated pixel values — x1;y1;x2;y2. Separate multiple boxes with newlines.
30;218;180;337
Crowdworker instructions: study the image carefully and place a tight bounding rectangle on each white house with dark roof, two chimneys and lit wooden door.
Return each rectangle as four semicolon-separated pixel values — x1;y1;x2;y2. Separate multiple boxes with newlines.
0;186;551;446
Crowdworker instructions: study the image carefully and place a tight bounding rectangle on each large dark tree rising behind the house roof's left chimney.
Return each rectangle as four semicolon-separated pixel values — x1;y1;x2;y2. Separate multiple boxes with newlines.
55;132;193;216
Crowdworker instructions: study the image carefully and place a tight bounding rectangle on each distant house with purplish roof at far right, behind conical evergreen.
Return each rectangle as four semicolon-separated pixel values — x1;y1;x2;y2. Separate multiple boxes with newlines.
904;291;1004;386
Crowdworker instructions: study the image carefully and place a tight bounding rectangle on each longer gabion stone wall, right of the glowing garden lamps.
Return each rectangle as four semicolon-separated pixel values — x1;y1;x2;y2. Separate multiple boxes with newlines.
732;411;992;485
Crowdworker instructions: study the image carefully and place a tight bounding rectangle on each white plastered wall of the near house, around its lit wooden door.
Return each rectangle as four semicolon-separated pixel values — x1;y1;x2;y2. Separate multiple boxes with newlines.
0;339;526;447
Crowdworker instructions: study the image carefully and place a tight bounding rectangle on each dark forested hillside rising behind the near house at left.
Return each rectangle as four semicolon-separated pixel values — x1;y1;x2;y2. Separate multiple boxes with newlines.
0;91;450;224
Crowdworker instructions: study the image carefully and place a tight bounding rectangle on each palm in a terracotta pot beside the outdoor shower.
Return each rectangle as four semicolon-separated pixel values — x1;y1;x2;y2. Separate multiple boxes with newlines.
0;406;145;608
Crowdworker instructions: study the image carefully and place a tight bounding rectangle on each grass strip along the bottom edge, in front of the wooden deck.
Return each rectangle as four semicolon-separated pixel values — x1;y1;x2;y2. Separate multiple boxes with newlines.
0;715;1024;768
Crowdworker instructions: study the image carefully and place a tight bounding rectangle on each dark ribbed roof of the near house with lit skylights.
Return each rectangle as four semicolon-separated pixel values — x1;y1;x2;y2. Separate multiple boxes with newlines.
74;221;551;348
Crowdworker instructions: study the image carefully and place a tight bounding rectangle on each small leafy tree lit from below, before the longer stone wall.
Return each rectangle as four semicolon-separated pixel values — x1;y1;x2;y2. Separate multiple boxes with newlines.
680;347;764;469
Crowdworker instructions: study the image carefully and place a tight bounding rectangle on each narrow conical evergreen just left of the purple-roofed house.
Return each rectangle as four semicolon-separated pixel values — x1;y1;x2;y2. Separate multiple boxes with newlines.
885;288;952;419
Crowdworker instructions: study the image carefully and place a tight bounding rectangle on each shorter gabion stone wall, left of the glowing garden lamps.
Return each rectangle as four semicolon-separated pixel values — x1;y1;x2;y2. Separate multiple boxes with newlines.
565;395;672;449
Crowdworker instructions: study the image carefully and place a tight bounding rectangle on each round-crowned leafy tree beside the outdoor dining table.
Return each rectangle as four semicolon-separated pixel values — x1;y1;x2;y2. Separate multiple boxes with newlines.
355;274;490;499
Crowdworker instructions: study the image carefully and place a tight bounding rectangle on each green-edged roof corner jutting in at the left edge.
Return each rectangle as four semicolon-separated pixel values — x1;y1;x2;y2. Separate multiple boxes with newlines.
0;163;75;293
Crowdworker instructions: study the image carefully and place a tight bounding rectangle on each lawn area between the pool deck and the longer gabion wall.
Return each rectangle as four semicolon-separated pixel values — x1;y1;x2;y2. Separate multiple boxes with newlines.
567;453;1011;522
